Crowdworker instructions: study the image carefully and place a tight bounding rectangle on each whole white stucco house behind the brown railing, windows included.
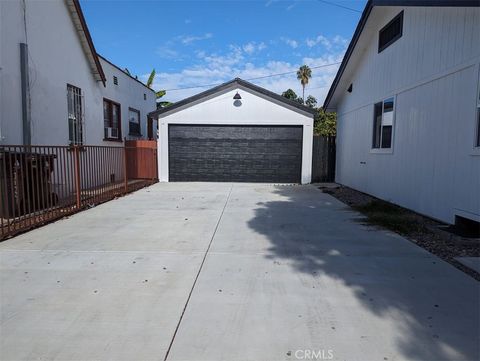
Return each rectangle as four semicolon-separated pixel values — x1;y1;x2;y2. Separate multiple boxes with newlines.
0;0;156;145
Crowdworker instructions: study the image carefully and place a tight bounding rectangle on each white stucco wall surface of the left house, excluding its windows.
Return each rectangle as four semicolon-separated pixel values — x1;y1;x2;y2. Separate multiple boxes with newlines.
0;0;155;145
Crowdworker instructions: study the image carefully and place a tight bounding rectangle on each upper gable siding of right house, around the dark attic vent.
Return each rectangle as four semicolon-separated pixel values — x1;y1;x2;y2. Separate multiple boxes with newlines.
337;7;480;114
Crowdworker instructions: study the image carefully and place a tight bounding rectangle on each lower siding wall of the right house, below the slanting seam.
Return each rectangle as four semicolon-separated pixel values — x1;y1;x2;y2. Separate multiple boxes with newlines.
337;65;480;223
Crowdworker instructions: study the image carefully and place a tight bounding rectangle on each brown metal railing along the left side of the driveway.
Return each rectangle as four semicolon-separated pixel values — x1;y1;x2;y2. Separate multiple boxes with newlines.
0;143;157;240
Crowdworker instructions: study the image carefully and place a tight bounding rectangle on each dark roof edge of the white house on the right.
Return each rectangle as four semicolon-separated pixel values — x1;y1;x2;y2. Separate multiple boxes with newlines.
323;0;480;110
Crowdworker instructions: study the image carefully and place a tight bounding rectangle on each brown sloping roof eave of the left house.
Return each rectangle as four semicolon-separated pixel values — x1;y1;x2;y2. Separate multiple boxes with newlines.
65;0;106;86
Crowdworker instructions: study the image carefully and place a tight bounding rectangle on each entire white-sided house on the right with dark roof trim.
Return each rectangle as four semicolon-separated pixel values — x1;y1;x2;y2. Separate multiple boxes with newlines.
324;0;480;223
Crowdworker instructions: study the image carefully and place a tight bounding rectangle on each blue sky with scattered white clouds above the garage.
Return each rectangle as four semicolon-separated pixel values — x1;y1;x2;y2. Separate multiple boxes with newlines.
81;0;366;105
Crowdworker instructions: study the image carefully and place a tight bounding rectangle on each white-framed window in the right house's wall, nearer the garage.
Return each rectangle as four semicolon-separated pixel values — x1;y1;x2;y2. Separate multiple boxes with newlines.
372;98;394;149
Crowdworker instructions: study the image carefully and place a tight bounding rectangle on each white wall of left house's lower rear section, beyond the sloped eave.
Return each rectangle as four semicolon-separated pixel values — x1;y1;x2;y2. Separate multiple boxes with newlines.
98;58;156;145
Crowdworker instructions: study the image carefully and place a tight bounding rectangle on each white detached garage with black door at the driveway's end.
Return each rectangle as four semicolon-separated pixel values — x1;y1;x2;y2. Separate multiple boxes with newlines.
150;78;314;184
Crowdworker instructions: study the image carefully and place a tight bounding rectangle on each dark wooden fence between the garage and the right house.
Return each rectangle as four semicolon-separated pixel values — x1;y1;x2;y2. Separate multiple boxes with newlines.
312;135;335;182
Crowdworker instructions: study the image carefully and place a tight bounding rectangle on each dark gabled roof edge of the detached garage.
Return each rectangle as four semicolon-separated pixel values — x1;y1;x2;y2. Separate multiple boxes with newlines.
148;78;316;117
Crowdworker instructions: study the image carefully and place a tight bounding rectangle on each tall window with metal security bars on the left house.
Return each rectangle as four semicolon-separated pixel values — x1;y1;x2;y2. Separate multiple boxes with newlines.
67;84;83;145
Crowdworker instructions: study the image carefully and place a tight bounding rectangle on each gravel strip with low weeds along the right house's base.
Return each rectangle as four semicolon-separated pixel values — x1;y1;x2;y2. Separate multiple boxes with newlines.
319;186;480;281
